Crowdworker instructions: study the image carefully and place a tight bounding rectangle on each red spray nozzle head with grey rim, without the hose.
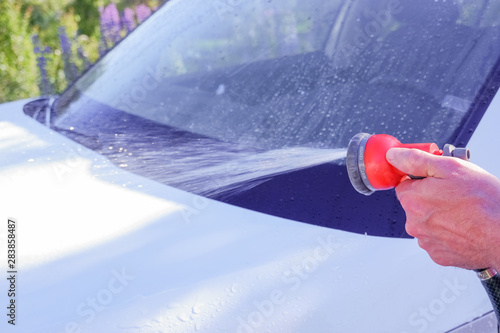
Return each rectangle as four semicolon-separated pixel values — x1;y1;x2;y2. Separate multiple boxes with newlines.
346;133;469;195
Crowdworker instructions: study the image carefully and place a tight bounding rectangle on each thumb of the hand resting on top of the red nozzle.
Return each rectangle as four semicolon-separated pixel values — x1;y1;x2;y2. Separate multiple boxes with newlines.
386;148;449;178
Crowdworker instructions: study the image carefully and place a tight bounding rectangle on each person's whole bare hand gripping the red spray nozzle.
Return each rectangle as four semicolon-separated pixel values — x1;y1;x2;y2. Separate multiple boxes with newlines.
386;148;500;271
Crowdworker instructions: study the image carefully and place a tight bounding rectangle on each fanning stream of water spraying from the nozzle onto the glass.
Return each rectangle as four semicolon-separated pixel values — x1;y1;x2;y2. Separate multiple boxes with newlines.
88;129;346;197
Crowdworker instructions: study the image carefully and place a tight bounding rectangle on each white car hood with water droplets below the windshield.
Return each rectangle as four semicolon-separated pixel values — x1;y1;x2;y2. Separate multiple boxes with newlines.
0;101;491;332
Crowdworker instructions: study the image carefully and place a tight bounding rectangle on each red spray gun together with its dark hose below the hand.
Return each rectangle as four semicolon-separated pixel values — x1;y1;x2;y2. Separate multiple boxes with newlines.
346;133;500;324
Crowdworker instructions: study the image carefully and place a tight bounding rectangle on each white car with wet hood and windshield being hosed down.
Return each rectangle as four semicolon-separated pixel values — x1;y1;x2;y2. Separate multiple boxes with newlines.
0;0;500;333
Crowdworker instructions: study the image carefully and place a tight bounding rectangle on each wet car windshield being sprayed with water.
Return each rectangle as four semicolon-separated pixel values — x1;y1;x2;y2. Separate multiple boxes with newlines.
47;0;500;237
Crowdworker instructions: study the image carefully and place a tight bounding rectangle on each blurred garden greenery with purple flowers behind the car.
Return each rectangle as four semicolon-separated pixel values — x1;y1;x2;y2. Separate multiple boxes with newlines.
0;0;164;103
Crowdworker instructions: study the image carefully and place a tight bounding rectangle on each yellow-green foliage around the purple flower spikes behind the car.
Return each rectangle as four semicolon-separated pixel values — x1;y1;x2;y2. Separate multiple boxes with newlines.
0;0;161;103
